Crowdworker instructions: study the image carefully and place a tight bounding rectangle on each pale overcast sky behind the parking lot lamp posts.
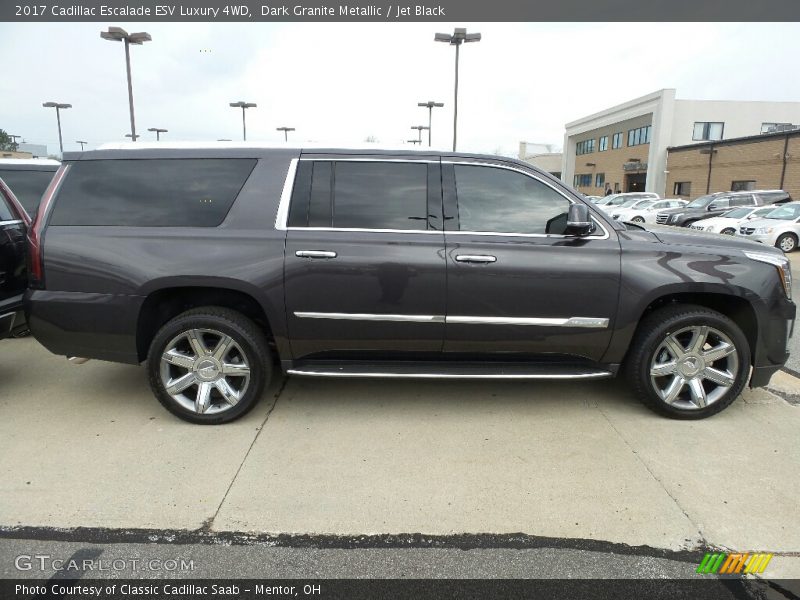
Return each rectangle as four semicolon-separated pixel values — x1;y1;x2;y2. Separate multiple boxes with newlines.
0;22;800;155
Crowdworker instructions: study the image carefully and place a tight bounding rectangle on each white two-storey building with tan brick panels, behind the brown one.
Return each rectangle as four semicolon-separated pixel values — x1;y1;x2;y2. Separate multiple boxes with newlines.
561;89;800;196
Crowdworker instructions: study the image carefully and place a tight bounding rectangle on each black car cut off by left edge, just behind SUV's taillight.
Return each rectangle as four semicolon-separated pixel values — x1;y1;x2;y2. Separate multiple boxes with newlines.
0;179;30;339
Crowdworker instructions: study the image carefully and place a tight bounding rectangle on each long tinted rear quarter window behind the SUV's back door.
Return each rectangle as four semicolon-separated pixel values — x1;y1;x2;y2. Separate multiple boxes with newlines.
50;158;256;227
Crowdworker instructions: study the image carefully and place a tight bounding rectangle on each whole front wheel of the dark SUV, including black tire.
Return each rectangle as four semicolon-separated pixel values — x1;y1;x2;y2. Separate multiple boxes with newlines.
626;304;750;419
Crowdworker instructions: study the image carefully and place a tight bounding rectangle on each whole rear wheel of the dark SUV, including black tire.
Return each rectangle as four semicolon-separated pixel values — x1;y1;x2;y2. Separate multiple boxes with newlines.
147;306;272;425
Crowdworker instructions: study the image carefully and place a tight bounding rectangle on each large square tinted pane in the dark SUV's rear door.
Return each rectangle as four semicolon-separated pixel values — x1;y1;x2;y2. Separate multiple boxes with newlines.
332;161;428;229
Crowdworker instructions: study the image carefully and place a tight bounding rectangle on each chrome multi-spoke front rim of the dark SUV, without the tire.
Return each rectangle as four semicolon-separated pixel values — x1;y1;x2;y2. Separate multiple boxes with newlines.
650;325;739;410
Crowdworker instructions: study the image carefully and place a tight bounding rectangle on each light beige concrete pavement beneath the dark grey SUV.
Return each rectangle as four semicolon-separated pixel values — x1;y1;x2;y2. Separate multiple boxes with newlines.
0;339;800;576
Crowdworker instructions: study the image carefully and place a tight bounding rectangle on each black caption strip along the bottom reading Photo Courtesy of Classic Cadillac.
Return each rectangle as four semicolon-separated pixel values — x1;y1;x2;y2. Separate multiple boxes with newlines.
0;577;800;600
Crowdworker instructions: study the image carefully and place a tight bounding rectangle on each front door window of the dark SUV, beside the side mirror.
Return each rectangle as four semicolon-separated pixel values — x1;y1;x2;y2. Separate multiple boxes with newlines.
455;165;569;234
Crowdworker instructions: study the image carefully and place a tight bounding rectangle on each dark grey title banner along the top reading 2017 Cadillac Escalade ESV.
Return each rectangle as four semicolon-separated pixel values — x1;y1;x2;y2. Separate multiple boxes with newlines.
0;0;800;22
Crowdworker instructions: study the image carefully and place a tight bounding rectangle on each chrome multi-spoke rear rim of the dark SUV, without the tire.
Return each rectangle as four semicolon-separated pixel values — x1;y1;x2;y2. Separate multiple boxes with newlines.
160;329;250;415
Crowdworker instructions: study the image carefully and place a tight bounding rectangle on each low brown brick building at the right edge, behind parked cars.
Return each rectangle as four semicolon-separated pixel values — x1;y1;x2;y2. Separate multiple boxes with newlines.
667;130;800;199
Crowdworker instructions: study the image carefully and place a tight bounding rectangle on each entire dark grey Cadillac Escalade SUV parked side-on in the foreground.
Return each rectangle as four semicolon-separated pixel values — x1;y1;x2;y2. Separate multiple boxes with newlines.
26;144;795;423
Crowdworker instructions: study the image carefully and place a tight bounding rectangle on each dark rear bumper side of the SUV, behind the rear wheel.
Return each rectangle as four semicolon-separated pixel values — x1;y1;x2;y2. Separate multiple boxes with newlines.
25;290;144;364
